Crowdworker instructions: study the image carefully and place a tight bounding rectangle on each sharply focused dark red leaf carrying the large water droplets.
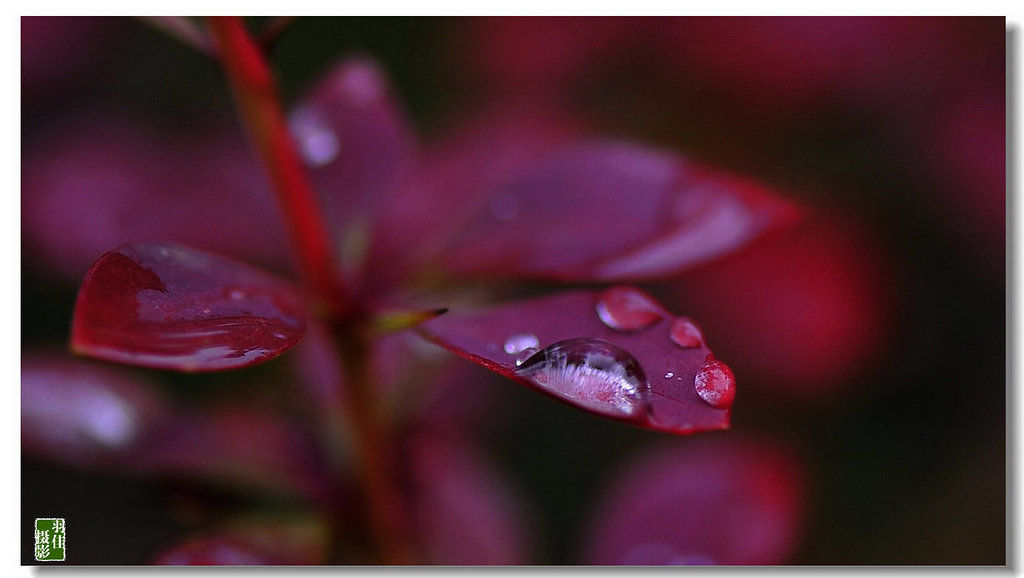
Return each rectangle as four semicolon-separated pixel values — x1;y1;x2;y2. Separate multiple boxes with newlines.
420;288;735;434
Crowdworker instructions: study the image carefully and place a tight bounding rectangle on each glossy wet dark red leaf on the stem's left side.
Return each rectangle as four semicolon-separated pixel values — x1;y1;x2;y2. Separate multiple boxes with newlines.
71;243;306;372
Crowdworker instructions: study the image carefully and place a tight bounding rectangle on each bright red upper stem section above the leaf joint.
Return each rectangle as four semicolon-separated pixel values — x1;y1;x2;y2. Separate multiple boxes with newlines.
208;16;349;317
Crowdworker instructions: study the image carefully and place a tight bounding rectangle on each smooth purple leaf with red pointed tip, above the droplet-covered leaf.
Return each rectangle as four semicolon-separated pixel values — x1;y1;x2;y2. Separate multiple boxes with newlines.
432;142;795;281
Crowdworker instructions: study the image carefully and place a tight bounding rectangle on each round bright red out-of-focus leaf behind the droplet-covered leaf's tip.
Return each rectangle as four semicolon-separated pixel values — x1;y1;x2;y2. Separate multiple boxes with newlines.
665;215;904;401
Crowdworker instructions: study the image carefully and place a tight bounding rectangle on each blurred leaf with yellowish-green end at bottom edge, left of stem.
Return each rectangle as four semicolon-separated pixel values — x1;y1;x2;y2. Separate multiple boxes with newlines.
153;514;329;566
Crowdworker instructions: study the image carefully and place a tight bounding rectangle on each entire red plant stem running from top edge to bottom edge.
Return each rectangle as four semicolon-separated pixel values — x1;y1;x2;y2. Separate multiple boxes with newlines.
209;16;415;565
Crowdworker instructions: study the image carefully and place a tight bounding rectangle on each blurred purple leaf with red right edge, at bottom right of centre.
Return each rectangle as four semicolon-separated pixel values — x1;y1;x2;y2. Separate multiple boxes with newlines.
582;436;806;566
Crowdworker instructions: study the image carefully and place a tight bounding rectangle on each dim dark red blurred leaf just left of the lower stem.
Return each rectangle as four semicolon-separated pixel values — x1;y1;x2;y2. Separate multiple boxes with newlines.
138;405;330;500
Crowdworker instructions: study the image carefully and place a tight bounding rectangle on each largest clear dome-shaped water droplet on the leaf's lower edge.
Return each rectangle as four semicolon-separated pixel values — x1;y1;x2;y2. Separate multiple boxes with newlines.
515;339;650;417
